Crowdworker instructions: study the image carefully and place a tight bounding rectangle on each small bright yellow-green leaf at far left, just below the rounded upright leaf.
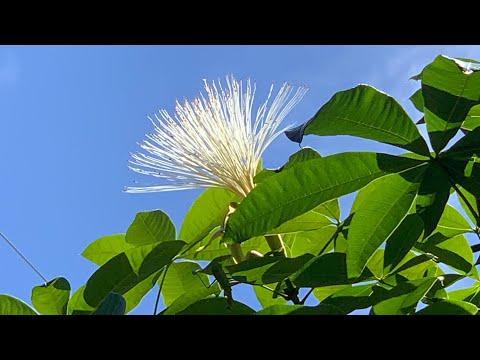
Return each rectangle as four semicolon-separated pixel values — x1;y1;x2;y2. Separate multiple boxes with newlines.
82;234;135;266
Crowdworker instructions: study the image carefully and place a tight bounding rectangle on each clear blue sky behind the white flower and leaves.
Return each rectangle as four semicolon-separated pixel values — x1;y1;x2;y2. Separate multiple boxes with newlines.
0;45;480;314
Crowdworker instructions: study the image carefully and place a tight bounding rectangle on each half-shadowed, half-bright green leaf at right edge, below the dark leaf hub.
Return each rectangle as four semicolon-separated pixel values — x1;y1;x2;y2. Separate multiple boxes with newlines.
415;233;475;274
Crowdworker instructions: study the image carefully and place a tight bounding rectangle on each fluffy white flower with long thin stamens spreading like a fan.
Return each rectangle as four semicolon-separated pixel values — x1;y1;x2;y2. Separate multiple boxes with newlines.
126;76;307;197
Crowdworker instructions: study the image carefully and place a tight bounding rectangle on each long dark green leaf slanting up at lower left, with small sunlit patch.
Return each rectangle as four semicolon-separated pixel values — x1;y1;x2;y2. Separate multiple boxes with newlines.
83;240;185;307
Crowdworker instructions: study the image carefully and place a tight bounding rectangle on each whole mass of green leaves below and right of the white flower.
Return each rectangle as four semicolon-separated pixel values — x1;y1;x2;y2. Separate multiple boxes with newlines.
0;56;480;315
